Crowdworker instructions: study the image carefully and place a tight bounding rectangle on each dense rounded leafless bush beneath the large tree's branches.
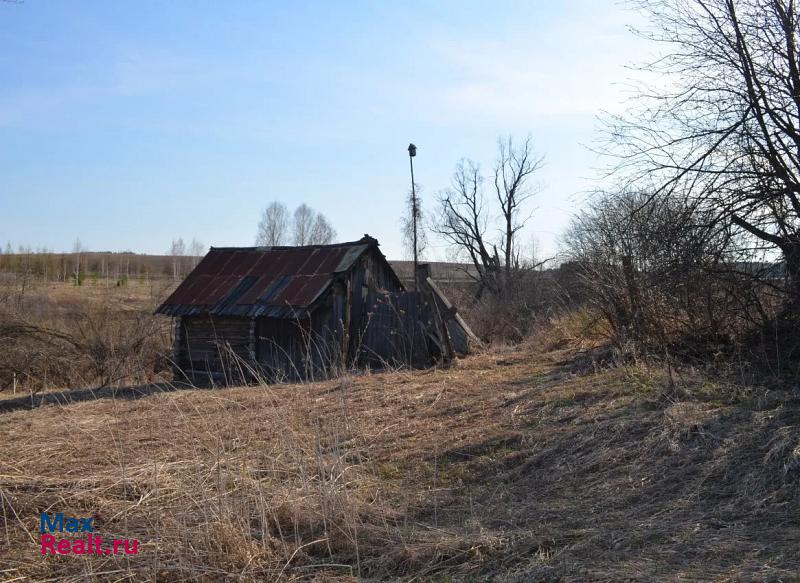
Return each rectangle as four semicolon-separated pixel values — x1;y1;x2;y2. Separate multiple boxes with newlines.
565;192;797;364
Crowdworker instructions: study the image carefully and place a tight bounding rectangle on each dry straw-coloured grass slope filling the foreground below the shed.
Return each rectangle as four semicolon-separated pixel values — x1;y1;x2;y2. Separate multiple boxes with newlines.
0;349;800;582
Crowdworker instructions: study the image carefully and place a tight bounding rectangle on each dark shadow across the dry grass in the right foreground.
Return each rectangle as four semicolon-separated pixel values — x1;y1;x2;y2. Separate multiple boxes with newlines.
412;376;800;582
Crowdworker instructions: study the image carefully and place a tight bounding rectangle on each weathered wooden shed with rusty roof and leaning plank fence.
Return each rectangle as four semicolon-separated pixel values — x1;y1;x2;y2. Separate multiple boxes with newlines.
156;235;477;384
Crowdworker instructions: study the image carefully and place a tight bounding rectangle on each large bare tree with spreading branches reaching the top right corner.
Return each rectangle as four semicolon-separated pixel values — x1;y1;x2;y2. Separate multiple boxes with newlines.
609;0;800;312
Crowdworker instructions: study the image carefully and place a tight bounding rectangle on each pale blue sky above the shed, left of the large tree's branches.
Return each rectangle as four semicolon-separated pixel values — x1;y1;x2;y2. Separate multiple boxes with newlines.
0;0;642;259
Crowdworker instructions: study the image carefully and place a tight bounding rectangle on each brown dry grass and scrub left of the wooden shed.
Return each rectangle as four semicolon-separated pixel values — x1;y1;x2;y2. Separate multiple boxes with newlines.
0;280;174;400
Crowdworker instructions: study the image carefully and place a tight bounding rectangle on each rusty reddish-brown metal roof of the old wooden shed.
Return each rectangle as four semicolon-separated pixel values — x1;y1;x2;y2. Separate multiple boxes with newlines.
156;236;378;318
